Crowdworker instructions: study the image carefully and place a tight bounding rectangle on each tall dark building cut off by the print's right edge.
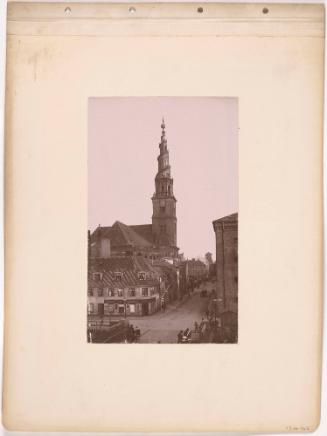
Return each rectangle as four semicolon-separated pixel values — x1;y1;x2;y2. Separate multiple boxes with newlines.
213;213;238;312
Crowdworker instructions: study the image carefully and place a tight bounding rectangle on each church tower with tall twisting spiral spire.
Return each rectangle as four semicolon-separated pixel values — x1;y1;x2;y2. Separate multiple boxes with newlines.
152;119;178;258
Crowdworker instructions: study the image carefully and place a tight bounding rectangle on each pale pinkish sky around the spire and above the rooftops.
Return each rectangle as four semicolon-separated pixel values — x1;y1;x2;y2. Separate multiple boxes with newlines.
88;97;238;259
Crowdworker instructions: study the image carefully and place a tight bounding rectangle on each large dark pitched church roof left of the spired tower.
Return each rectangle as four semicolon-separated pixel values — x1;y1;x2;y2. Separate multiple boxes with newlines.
91;221;153;247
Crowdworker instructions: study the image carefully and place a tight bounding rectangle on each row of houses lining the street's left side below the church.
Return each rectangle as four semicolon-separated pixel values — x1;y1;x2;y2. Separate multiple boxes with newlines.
88;252;207;317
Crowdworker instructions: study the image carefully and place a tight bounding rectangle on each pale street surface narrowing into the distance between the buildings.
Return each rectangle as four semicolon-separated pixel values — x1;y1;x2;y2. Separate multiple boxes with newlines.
129;283;213;343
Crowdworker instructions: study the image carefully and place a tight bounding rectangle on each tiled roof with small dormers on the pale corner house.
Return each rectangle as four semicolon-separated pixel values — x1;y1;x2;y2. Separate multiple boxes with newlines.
88;256;159;289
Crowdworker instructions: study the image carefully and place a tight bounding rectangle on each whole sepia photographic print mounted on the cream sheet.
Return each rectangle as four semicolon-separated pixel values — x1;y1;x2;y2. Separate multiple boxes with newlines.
86;97;238;344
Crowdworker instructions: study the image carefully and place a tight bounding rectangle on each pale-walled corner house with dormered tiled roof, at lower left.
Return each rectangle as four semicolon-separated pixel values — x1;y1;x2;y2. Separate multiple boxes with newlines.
88;257;165;317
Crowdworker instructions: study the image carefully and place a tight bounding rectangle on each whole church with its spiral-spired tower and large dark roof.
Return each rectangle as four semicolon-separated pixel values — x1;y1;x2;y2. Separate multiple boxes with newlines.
89;120;178;261
